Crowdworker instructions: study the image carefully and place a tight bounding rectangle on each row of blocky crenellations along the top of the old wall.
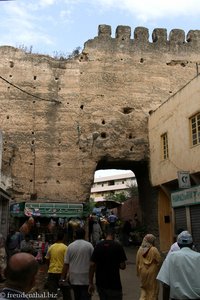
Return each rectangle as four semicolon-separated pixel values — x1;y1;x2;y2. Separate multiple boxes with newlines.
85;25;200;52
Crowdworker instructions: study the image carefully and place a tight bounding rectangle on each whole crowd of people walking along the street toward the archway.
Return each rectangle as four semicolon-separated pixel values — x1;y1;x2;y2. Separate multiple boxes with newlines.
0;214;200;300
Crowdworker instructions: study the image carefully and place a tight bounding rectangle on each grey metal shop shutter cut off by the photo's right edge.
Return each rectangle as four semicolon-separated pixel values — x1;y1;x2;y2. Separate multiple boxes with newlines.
190;205;200;251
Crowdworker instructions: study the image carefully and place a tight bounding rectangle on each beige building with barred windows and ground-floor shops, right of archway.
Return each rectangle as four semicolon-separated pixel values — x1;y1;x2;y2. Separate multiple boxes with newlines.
149;75;200;251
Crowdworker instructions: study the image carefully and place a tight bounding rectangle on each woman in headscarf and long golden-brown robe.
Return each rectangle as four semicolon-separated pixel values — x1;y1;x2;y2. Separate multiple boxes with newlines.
136;234;161;300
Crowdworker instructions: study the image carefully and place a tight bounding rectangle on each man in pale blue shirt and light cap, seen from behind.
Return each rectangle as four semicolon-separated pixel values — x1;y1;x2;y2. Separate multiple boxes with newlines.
157;231;200;300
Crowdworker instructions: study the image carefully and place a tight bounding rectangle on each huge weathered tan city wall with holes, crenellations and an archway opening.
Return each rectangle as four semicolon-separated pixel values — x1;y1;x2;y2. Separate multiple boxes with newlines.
0;25;200;229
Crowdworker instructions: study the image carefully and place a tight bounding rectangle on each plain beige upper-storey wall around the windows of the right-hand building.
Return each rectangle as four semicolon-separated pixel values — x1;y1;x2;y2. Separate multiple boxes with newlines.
149;76;200;186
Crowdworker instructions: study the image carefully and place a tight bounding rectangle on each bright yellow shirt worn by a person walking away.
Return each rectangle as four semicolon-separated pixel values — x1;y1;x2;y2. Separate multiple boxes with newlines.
45;243;67;274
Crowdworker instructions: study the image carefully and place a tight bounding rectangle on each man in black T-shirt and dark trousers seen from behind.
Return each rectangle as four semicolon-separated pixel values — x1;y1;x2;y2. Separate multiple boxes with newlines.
89;228;127;300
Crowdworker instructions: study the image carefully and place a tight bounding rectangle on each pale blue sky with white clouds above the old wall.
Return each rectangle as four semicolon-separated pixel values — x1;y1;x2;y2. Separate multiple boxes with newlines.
0;0;200;56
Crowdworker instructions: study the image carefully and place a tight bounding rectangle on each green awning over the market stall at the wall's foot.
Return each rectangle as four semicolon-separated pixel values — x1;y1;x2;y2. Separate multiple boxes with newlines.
10;202;83;218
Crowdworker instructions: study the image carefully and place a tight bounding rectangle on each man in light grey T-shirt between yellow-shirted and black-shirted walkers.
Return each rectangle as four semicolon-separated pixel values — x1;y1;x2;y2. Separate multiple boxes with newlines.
62;228;94;300
